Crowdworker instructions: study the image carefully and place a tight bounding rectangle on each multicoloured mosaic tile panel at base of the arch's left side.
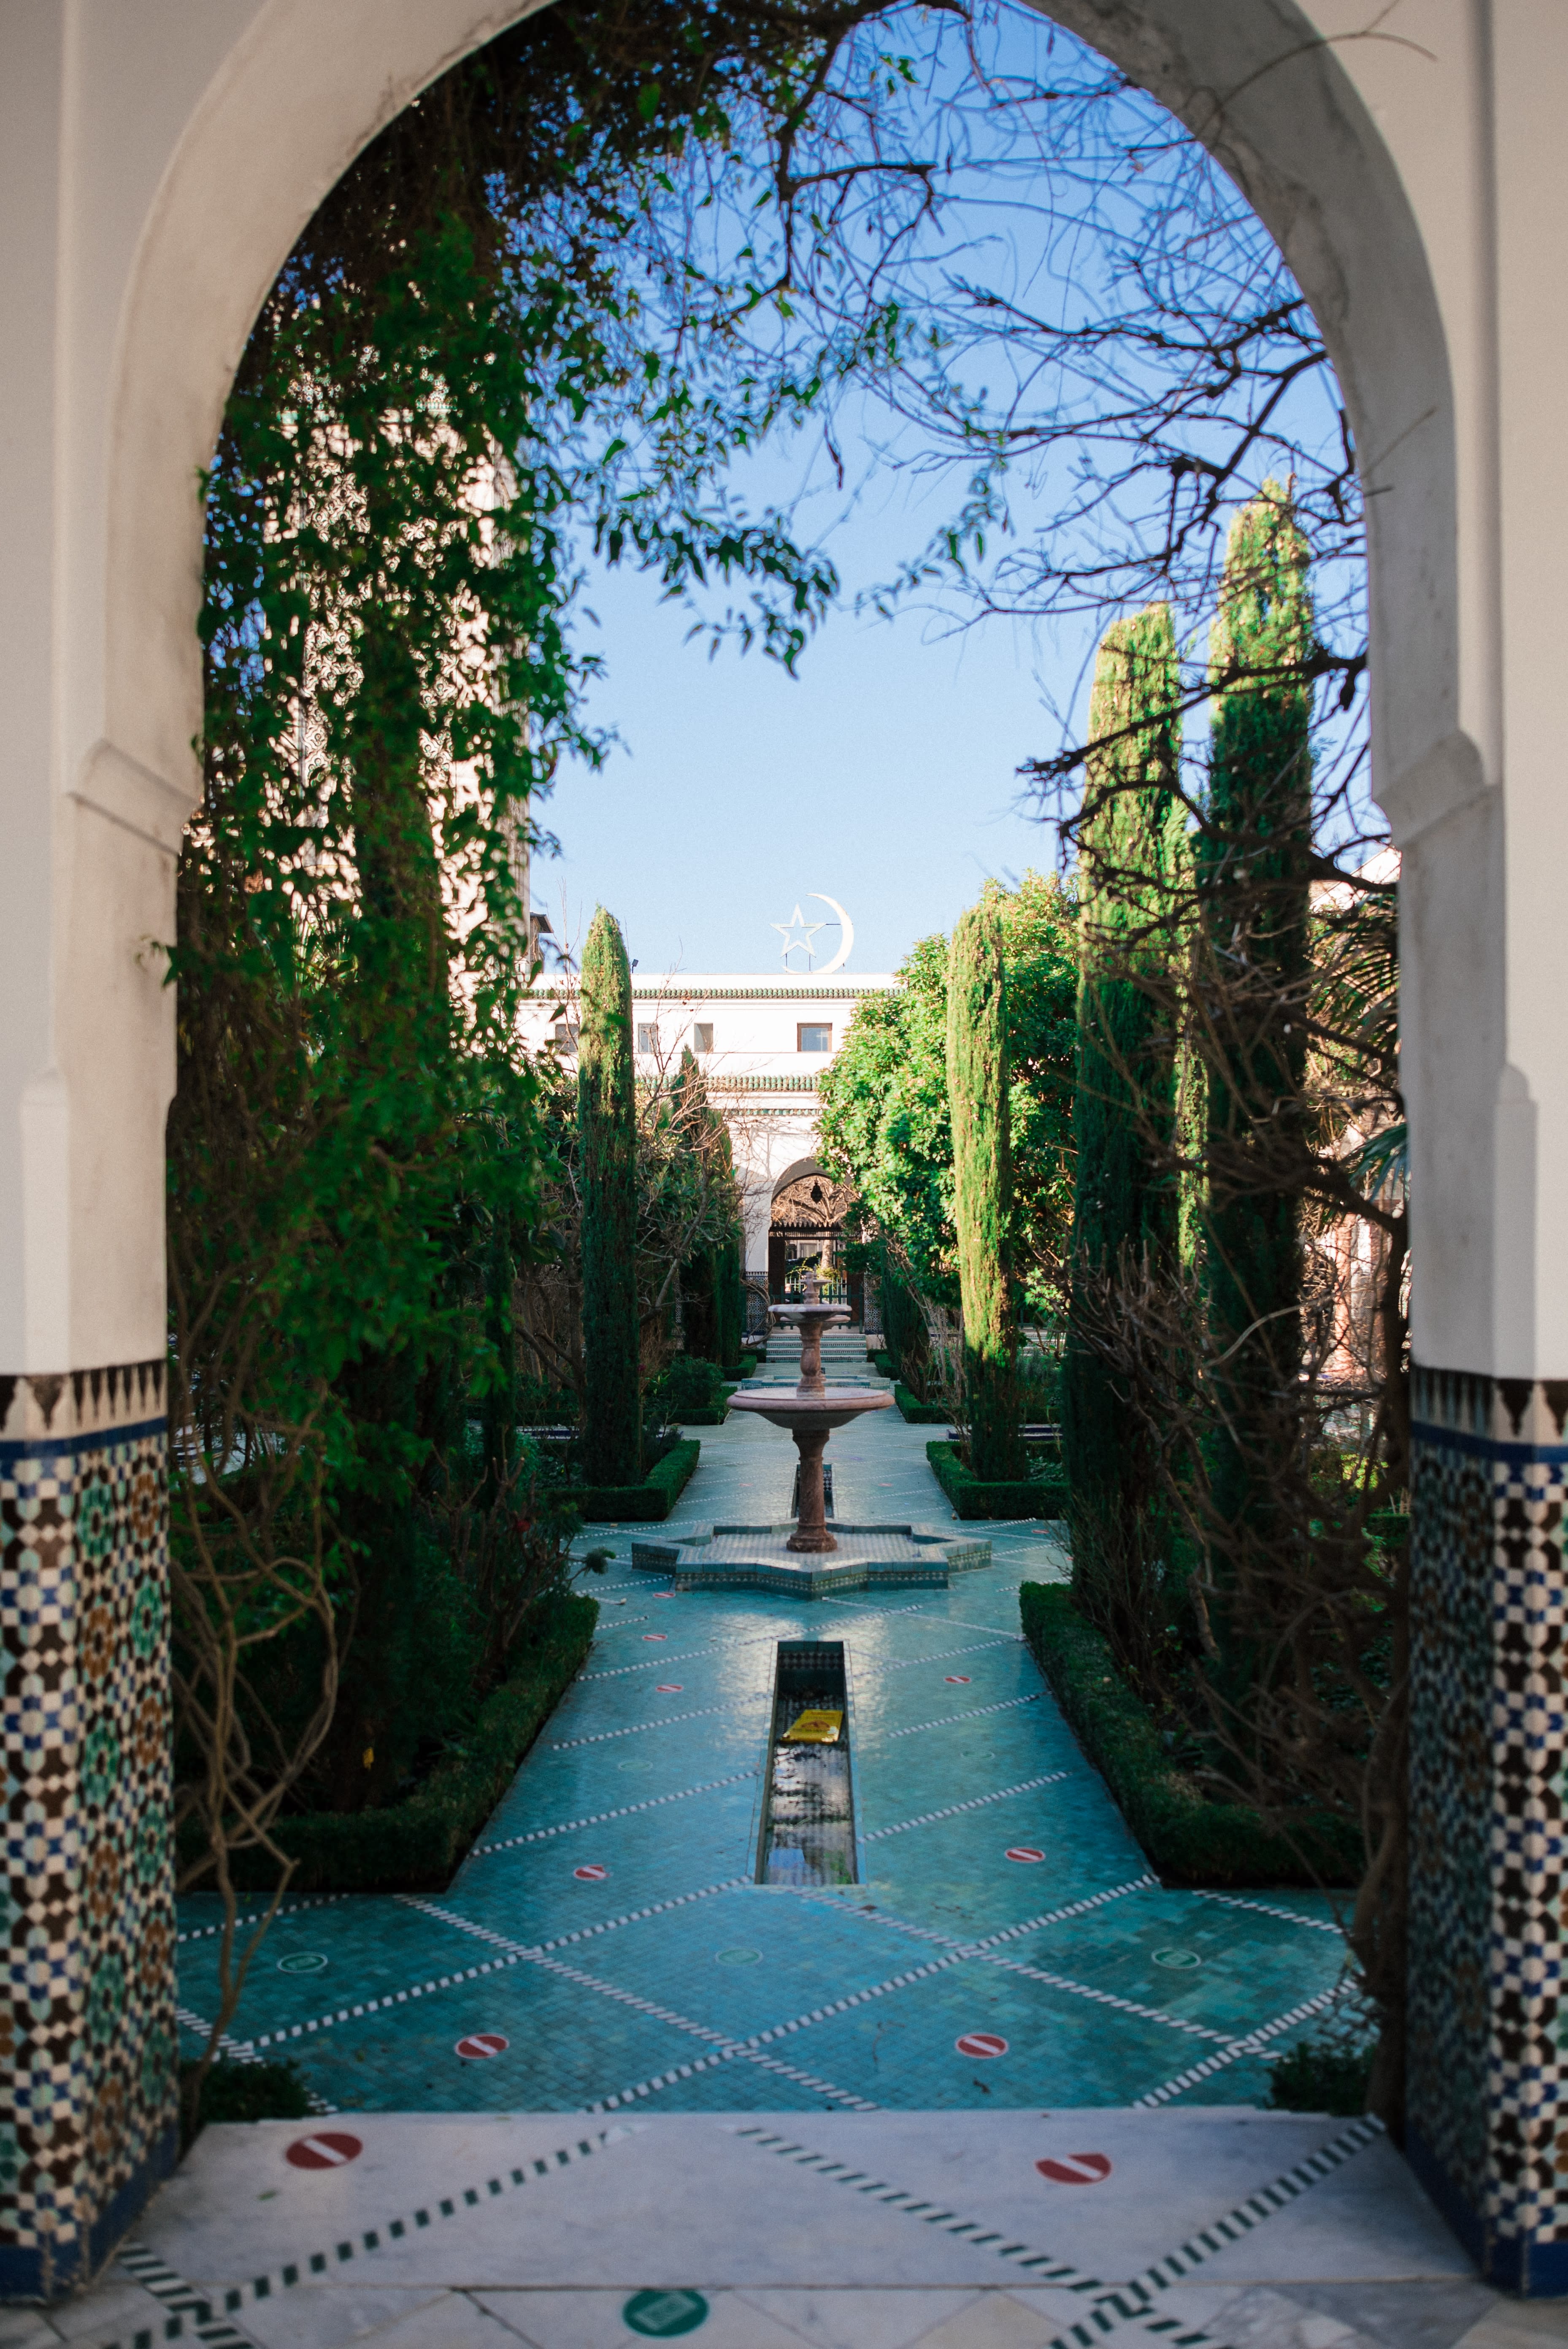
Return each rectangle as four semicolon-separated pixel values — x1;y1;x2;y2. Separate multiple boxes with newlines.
0;1362;176;2300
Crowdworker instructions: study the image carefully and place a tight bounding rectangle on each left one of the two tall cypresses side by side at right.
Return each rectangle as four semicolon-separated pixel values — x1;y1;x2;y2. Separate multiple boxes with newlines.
1061;604;1185;1658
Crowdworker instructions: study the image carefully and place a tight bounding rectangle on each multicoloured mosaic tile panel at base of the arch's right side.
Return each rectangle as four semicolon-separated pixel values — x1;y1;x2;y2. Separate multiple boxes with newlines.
1408;1370;1568;2292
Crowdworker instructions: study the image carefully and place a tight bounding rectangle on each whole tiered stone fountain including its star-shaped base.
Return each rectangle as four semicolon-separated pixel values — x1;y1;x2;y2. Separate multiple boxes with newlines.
631;1271;991;1600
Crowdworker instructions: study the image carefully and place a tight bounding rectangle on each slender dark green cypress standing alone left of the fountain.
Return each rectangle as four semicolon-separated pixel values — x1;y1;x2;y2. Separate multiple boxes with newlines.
577;907;643;1484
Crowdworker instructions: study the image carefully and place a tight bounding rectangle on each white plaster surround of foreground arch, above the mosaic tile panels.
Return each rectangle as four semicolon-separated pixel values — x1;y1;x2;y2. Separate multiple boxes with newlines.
0;0;1568;1376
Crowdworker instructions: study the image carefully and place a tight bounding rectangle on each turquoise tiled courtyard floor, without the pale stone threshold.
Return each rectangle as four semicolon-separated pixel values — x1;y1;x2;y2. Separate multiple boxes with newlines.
181;1372;1343;2112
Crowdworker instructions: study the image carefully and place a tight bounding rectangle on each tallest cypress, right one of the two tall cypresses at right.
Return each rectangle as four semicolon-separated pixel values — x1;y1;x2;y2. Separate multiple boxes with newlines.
1202;481;1314;1644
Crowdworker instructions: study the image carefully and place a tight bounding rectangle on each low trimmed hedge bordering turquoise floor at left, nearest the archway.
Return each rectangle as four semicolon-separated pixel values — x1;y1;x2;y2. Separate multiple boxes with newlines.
215;1588;594;1898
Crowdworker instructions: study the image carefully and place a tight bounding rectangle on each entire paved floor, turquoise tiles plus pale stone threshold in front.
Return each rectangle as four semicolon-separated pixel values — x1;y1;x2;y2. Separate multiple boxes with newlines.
12;1365;1568;2349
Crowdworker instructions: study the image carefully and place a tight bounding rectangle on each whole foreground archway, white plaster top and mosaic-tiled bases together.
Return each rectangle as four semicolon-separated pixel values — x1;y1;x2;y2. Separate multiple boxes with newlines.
0;0;1568;2292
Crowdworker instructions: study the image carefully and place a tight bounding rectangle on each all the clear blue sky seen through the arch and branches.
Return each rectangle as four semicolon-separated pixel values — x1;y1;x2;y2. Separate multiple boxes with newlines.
533;9;1340;973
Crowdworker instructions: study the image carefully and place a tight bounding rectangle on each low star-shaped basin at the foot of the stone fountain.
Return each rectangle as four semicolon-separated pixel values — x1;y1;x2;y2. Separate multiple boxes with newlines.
631;1517;991;1600
